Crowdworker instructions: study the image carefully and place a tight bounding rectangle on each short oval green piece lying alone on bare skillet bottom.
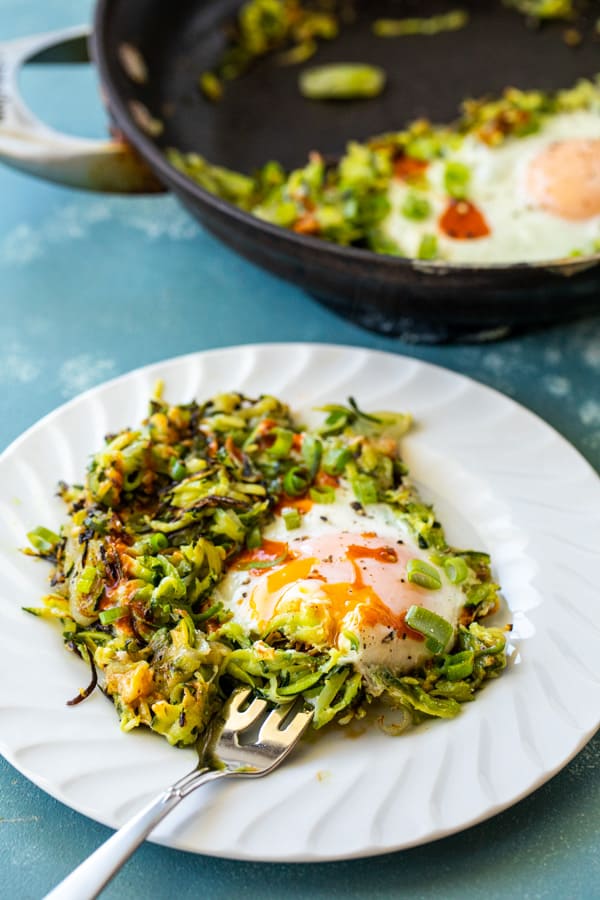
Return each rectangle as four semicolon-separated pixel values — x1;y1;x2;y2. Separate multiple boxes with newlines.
298;63;386;100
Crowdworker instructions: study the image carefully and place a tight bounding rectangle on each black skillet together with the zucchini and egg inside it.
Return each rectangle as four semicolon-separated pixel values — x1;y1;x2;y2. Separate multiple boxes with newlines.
4;0;598;340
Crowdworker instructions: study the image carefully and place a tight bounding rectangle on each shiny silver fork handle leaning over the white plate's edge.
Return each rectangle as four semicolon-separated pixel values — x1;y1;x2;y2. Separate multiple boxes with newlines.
46;769;228;900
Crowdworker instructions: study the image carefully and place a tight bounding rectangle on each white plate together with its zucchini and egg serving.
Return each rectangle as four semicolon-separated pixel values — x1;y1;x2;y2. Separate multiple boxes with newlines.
0;345;598;861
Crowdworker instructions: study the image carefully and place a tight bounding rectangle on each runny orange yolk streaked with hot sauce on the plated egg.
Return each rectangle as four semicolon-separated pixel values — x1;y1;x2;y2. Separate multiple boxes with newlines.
239;532;432;641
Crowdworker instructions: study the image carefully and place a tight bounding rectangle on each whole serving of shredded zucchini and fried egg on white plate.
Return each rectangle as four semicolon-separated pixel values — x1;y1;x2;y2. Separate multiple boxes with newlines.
29;393;506;746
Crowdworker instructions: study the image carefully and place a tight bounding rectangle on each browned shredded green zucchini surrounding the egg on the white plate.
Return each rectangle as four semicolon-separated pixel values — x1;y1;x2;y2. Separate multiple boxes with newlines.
27;393;506;746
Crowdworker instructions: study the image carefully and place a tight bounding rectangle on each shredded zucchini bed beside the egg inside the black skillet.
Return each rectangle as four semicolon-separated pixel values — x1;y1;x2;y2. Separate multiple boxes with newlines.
167;76;600;259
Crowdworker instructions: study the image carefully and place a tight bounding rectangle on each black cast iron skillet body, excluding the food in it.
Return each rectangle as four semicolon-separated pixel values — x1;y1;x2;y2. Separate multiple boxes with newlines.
92;0;600;341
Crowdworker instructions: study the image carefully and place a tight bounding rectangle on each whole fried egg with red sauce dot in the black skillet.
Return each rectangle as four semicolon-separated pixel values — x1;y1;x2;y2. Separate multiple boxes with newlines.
383;109;600;264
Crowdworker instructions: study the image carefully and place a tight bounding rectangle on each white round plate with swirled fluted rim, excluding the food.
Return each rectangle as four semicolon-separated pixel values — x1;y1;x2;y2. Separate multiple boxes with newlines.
0;344;600;861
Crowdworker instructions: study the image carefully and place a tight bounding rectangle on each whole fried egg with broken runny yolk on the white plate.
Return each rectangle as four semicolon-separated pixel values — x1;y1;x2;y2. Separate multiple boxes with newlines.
215;487;465;673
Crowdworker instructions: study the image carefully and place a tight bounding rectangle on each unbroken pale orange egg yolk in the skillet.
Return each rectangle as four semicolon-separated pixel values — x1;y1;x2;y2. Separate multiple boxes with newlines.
526;138;600;220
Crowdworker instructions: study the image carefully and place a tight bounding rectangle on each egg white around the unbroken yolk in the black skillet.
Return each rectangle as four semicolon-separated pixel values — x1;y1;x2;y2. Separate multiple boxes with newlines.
383;109;600;263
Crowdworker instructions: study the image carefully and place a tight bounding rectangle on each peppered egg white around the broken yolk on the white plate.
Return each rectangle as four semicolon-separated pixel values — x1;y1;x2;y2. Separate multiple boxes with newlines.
214;487;465;673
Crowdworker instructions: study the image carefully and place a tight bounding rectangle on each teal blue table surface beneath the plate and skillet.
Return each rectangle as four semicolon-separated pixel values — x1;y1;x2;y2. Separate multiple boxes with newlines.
0;0;600;900
